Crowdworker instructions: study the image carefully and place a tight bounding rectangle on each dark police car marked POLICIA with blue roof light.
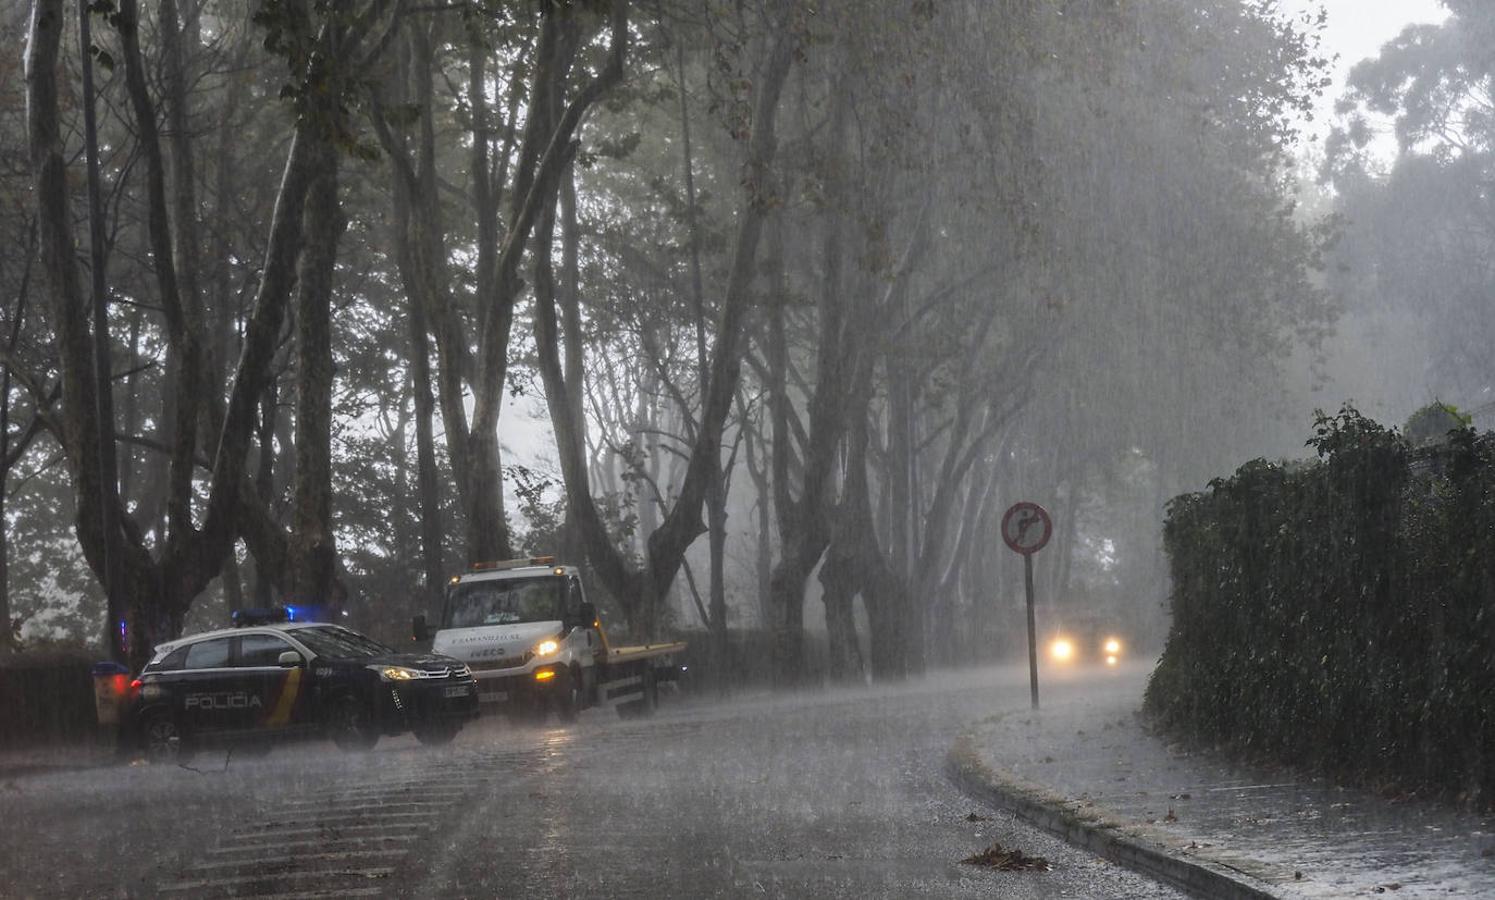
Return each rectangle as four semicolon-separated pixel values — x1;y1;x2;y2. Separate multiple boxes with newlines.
129;610;478;762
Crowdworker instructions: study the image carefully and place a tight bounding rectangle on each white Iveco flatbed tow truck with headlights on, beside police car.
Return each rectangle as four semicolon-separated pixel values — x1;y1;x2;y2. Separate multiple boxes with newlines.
411;556;685;722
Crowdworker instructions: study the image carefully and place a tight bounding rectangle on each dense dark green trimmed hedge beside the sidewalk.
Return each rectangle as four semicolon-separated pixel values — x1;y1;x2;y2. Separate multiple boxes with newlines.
1147;408;1495;806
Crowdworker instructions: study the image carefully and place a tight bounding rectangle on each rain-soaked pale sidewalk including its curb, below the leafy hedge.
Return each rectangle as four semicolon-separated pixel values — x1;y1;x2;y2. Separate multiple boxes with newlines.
951;670;1495;899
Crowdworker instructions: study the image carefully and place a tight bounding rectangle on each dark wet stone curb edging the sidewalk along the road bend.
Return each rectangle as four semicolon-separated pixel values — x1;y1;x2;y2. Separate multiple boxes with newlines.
945;733;1280;900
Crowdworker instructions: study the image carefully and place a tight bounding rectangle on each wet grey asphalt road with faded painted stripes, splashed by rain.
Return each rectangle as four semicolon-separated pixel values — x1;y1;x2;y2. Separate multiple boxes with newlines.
0;668;1178;899
